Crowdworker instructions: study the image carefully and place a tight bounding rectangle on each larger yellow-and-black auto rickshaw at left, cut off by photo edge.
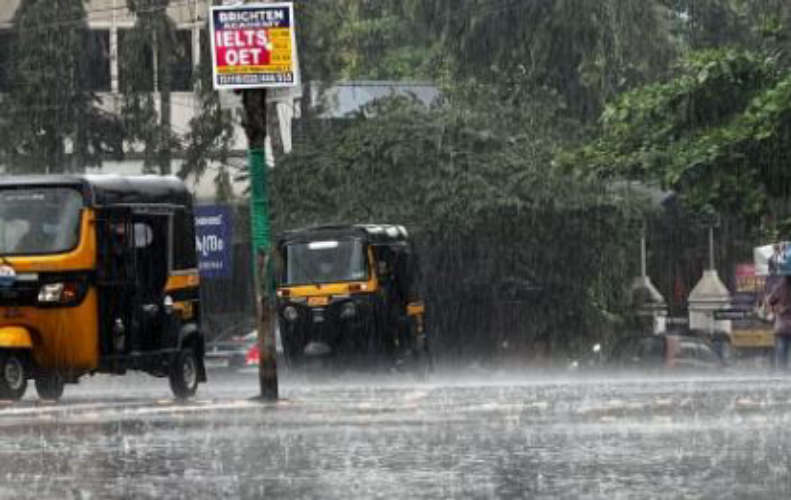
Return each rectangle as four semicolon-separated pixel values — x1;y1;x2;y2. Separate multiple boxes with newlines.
0;175;206;399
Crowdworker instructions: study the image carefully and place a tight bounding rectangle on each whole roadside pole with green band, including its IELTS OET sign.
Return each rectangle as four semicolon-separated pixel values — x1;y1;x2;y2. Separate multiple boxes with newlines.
209;2;299;400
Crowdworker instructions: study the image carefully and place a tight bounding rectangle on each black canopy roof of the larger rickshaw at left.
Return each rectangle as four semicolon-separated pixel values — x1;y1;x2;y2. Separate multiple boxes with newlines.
0;175;192;207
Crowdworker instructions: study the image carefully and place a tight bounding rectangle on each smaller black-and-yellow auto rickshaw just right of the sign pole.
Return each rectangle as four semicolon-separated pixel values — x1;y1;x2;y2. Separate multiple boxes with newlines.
277;224;431;373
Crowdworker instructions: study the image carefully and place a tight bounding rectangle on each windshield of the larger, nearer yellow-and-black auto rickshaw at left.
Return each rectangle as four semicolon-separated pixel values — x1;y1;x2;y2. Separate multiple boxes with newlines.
0;187;83;255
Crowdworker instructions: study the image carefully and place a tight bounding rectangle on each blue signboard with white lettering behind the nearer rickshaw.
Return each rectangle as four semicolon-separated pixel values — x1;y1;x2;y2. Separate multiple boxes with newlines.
195;205;233;278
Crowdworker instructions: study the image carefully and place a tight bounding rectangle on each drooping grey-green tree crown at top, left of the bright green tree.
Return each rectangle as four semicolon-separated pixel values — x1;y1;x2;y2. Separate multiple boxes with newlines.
409;0;674;123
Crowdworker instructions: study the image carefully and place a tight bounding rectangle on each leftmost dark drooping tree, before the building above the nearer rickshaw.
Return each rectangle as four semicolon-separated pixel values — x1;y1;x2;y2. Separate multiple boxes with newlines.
0;0;123;173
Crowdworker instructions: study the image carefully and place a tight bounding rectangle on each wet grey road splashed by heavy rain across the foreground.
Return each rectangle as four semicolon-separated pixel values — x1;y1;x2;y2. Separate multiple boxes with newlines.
0;373;791;499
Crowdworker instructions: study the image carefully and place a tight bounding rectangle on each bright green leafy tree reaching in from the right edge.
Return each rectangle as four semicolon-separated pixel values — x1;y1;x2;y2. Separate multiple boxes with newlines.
555;0;791;314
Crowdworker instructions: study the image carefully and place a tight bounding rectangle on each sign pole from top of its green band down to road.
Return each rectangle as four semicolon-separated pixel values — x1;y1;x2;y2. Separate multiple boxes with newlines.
248;148;278;400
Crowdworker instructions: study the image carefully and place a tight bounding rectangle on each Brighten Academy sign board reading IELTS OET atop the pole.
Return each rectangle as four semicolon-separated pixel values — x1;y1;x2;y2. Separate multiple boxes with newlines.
209;3;299;90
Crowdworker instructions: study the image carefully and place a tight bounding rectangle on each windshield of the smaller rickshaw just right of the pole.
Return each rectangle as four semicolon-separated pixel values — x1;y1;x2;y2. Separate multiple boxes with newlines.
284;239;367;285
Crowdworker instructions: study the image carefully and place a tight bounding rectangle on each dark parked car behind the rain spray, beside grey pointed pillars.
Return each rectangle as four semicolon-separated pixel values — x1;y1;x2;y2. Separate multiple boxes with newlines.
607;334;725;371
